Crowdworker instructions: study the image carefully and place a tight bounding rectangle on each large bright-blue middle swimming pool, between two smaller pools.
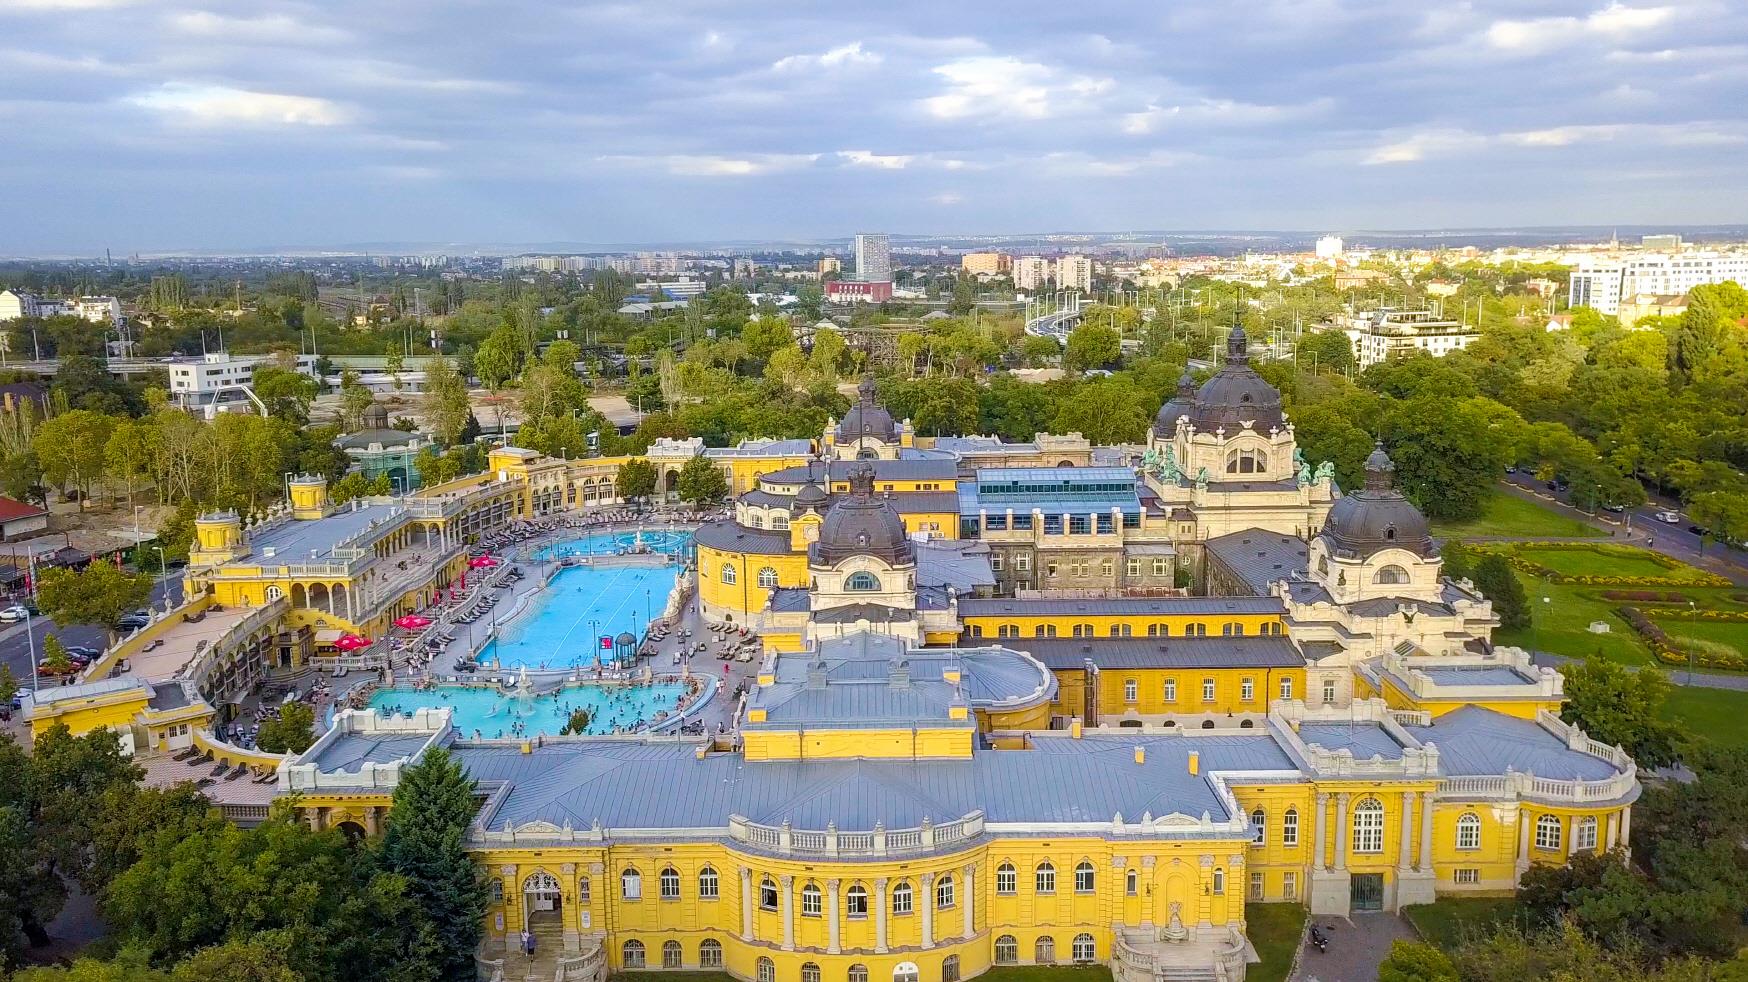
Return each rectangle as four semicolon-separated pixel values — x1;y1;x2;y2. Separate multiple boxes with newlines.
479;564;680;671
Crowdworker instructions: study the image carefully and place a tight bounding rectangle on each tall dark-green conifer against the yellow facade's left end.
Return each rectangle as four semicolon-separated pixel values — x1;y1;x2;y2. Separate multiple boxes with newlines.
383;748;488;982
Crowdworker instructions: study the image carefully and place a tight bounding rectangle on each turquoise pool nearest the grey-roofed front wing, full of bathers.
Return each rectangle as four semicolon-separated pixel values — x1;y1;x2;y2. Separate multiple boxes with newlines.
371;681;685;739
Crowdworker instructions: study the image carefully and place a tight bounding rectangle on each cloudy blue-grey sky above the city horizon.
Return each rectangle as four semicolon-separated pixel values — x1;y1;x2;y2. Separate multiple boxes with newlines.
0;0;1748;253
